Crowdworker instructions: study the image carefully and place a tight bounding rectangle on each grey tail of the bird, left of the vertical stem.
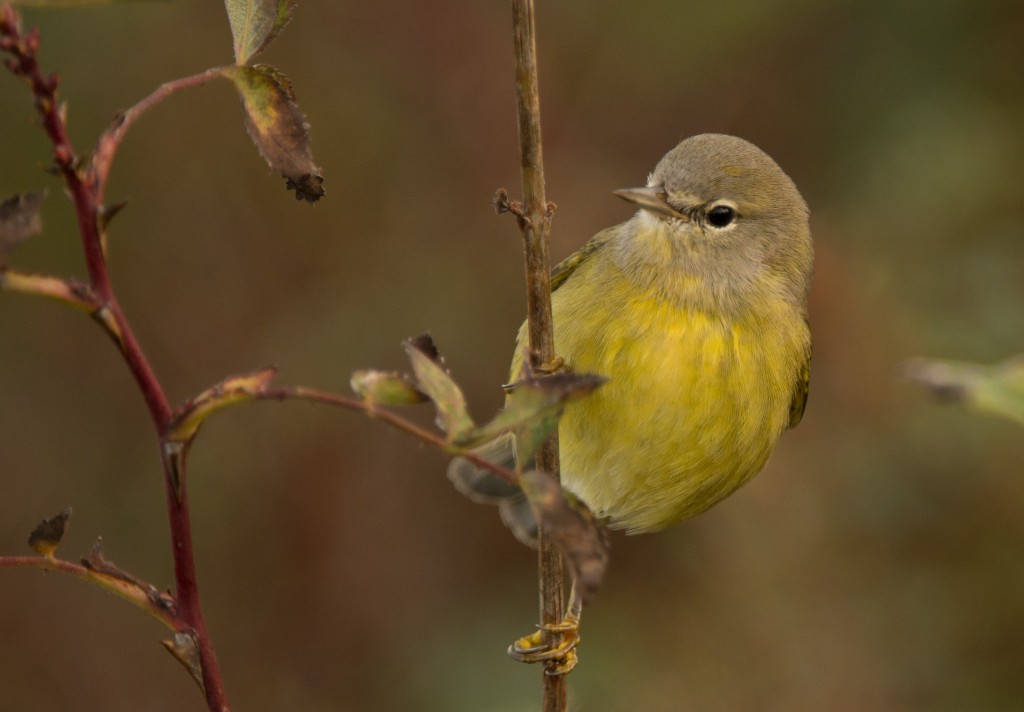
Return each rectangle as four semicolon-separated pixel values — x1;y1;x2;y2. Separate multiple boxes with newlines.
449;434;537;548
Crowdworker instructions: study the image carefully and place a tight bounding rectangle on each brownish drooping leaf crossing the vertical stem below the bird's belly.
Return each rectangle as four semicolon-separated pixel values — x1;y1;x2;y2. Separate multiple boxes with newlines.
519;470;608;603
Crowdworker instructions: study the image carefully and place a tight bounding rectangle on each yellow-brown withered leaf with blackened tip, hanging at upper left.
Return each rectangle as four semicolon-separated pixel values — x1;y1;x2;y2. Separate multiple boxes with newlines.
222;65;324;203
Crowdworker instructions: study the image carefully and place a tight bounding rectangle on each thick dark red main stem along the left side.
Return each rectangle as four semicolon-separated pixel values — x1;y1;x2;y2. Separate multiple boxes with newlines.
0;5;229;712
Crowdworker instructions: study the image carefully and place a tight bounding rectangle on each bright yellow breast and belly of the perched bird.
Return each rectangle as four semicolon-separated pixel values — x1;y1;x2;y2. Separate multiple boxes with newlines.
553;276;806;533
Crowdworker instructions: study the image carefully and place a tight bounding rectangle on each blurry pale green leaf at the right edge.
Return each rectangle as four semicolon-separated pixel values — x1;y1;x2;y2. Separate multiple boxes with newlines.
904;354;1024;425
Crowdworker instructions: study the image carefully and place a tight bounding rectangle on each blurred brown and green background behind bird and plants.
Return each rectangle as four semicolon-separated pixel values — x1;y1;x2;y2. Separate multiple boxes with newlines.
0;0;1024;712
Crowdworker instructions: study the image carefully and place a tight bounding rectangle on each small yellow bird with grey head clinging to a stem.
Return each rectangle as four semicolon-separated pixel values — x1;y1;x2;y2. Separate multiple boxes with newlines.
449;134;813;542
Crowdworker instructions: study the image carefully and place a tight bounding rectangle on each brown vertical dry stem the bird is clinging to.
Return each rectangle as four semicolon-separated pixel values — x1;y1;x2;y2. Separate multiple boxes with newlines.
512;0;566;712
